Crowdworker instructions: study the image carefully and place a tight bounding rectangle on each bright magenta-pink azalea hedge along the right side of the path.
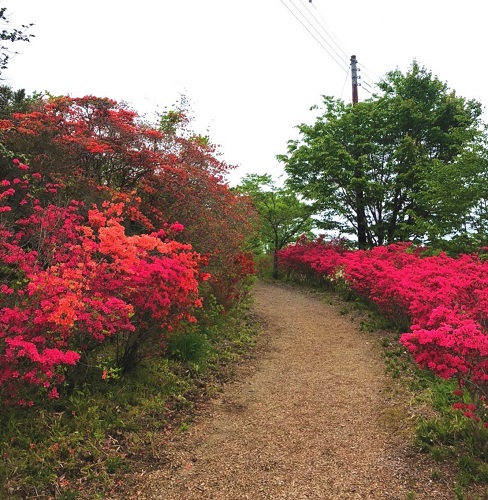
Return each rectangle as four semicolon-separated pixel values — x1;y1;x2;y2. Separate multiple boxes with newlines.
280;239;488;422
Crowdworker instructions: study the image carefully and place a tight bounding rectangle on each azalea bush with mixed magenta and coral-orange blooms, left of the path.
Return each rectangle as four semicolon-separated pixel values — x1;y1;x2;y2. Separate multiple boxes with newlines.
0;161;208;404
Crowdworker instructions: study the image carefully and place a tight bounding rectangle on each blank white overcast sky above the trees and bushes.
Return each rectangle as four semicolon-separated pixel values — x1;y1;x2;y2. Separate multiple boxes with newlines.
4;0;488;184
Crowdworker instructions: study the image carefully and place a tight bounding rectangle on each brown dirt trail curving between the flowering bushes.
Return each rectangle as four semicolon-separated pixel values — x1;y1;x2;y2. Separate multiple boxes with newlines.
130;283;454;500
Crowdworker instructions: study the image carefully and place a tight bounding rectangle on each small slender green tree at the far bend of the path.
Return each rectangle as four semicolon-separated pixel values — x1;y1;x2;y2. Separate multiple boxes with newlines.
237;174;314;278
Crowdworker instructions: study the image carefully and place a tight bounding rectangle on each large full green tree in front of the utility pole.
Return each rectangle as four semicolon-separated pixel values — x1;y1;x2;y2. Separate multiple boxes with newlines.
278;62;487;248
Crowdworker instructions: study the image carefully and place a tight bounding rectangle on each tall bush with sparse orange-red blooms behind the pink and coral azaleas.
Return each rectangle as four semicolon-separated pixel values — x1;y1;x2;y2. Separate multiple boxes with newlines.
0;96;254;308
